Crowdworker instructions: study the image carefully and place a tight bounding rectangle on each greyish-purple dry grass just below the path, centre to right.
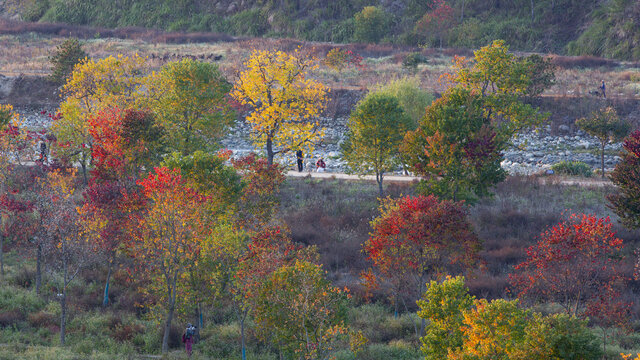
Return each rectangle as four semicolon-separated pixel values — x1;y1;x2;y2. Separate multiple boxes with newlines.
282;177;640;298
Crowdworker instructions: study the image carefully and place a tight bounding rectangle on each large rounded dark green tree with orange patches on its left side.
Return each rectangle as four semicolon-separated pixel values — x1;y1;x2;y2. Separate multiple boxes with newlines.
402;89;506;201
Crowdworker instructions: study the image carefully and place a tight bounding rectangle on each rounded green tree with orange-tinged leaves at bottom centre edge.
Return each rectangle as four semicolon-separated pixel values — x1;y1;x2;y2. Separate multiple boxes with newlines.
254;260;347;359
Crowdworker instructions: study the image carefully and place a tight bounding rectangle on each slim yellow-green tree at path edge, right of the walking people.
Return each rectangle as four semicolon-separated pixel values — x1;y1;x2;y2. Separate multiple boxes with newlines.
342;93;411;197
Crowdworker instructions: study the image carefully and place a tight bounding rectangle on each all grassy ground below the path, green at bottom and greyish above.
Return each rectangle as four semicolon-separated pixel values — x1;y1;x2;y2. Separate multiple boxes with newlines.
0;177;640;360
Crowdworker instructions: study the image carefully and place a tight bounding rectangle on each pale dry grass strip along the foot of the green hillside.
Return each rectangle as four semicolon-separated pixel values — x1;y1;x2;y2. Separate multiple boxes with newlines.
0;27;640;100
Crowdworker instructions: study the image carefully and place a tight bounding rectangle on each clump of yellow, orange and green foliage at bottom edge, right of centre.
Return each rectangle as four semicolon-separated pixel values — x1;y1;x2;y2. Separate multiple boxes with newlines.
418;277;602;360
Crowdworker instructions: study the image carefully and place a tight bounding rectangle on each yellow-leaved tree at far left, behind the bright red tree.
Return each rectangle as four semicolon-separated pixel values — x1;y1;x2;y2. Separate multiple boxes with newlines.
53;55;148;183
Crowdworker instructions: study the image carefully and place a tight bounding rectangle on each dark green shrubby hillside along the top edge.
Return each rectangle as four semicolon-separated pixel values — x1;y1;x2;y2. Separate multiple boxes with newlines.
5;0;640;60
